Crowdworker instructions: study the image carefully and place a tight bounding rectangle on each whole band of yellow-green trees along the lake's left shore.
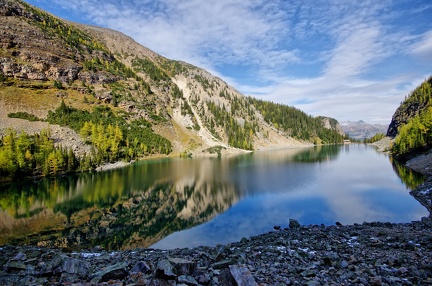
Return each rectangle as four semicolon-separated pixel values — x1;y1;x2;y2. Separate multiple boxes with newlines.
0;101;172;179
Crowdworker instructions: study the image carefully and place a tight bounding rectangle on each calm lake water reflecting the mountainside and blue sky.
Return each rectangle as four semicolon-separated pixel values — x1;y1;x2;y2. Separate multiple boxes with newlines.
0;145;428;249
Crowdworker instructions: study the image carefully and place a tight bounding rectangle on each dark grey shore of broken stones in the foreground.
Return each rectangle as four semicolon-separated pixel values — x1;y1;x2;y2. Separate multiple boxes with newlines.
0;142;432;285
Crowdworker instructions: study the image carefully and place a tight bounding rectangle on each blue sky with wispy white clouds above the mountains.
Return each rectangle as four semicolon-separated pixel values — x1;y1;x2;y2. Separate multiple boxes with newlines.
27;0;432;124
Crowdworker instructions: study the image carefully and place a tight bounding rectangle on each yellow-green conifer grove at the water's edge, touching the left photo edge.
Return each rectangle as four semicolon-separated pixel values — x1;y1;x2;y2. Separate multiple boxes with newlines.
0;129;80;179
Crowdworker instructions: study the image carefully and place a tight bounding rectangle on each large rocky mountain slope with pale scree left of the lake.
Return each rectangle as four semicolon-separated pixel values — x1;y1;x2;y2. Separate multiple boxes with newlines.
0;0;341;168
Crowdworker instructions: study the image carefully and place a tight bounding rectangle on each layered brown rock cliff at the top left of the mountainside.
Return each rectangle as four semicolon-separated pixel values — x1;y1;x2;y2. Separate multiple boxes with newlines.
0;0;114;83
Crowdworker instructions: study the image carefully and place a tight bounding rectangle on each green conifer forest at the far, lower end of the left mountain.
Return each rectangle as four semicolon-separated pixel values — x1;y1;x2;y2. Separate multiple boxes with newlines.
248;97;343;144
